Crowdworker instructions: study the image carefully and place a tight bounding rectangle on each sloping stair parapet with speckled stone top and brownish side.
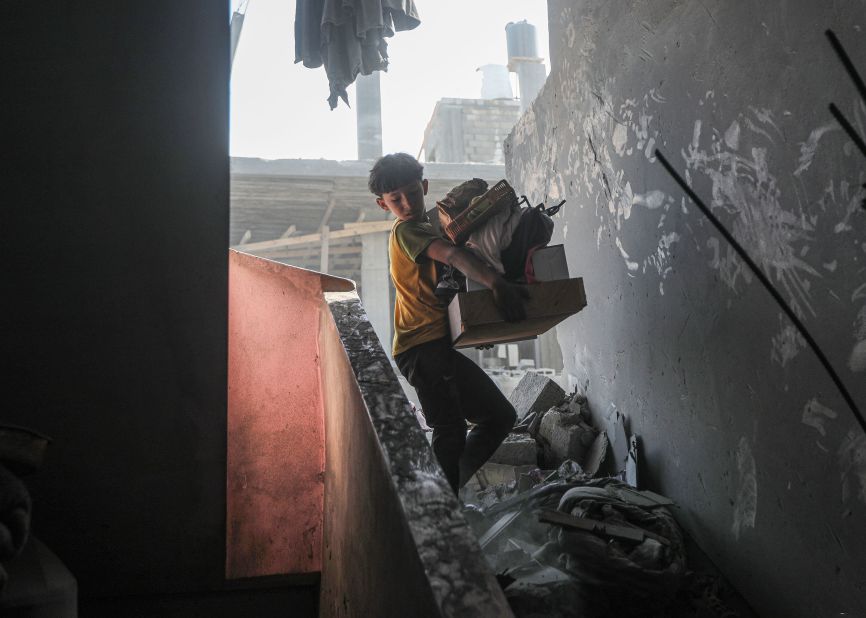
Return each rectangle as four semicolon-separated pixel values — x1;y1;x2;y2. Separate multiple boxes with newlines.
319;293;512;618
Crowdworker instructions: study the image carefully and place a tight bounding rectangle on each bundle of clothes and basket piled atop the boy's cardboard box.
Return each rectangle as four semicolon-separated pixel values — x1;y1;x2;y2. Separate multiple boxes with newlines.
436;178;565;302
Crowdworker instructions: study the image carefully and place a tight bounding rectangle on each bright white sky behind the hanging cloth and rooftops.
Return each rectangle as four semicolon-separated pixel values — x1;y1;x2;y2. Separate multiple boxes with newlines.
230;0;549;160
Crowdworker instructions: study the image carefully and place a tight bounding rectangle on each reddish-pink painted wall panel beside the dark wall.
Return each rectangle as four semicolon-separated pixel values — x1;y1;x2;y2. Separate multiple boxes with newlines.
226;251;325;578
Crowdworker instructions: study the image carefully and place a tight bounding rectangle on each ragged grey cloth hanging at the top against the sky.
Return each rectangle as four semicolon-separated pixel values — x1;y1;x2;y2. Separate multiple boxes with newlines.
295;0;421;109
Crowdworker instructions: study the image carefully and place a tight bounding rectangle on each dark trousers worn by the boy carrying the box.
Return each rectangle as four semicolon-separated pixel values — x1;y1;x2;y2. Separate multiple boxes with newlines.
394;337;517;493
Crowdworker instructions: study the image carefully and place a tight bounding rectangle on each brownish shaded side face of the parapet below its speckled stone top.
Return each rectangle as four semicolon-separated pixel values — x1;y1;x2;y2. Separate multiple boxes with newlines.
319;302;438;617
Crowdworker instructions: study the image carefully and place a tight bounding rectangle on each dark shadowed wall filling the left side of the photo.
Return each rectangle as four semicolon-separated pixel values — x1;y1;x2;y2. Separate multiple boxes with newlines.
0;0;229;597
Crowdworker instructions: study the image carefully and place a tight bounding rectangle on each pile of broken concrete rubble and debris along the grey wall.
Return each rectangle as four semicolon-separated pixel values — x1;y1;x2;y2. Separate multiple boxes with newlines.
460;374;741;618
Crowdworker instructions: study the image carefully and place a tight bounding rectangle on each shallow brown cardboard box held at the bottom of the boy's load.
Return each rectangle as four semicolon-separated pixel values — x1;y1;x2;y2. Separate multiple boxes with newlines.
448;278;586;348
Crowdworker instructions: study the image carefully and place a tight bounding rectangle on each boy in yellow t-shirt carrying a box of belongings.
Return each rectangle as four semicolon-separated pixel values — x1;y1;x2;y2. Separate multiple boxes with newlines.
369;153;526;493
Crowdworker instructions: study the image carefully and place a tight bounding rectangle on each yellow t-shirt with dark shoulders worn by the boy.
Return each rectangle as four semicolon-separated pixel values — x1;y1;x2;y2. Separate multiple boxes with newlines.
388;219;448;356
